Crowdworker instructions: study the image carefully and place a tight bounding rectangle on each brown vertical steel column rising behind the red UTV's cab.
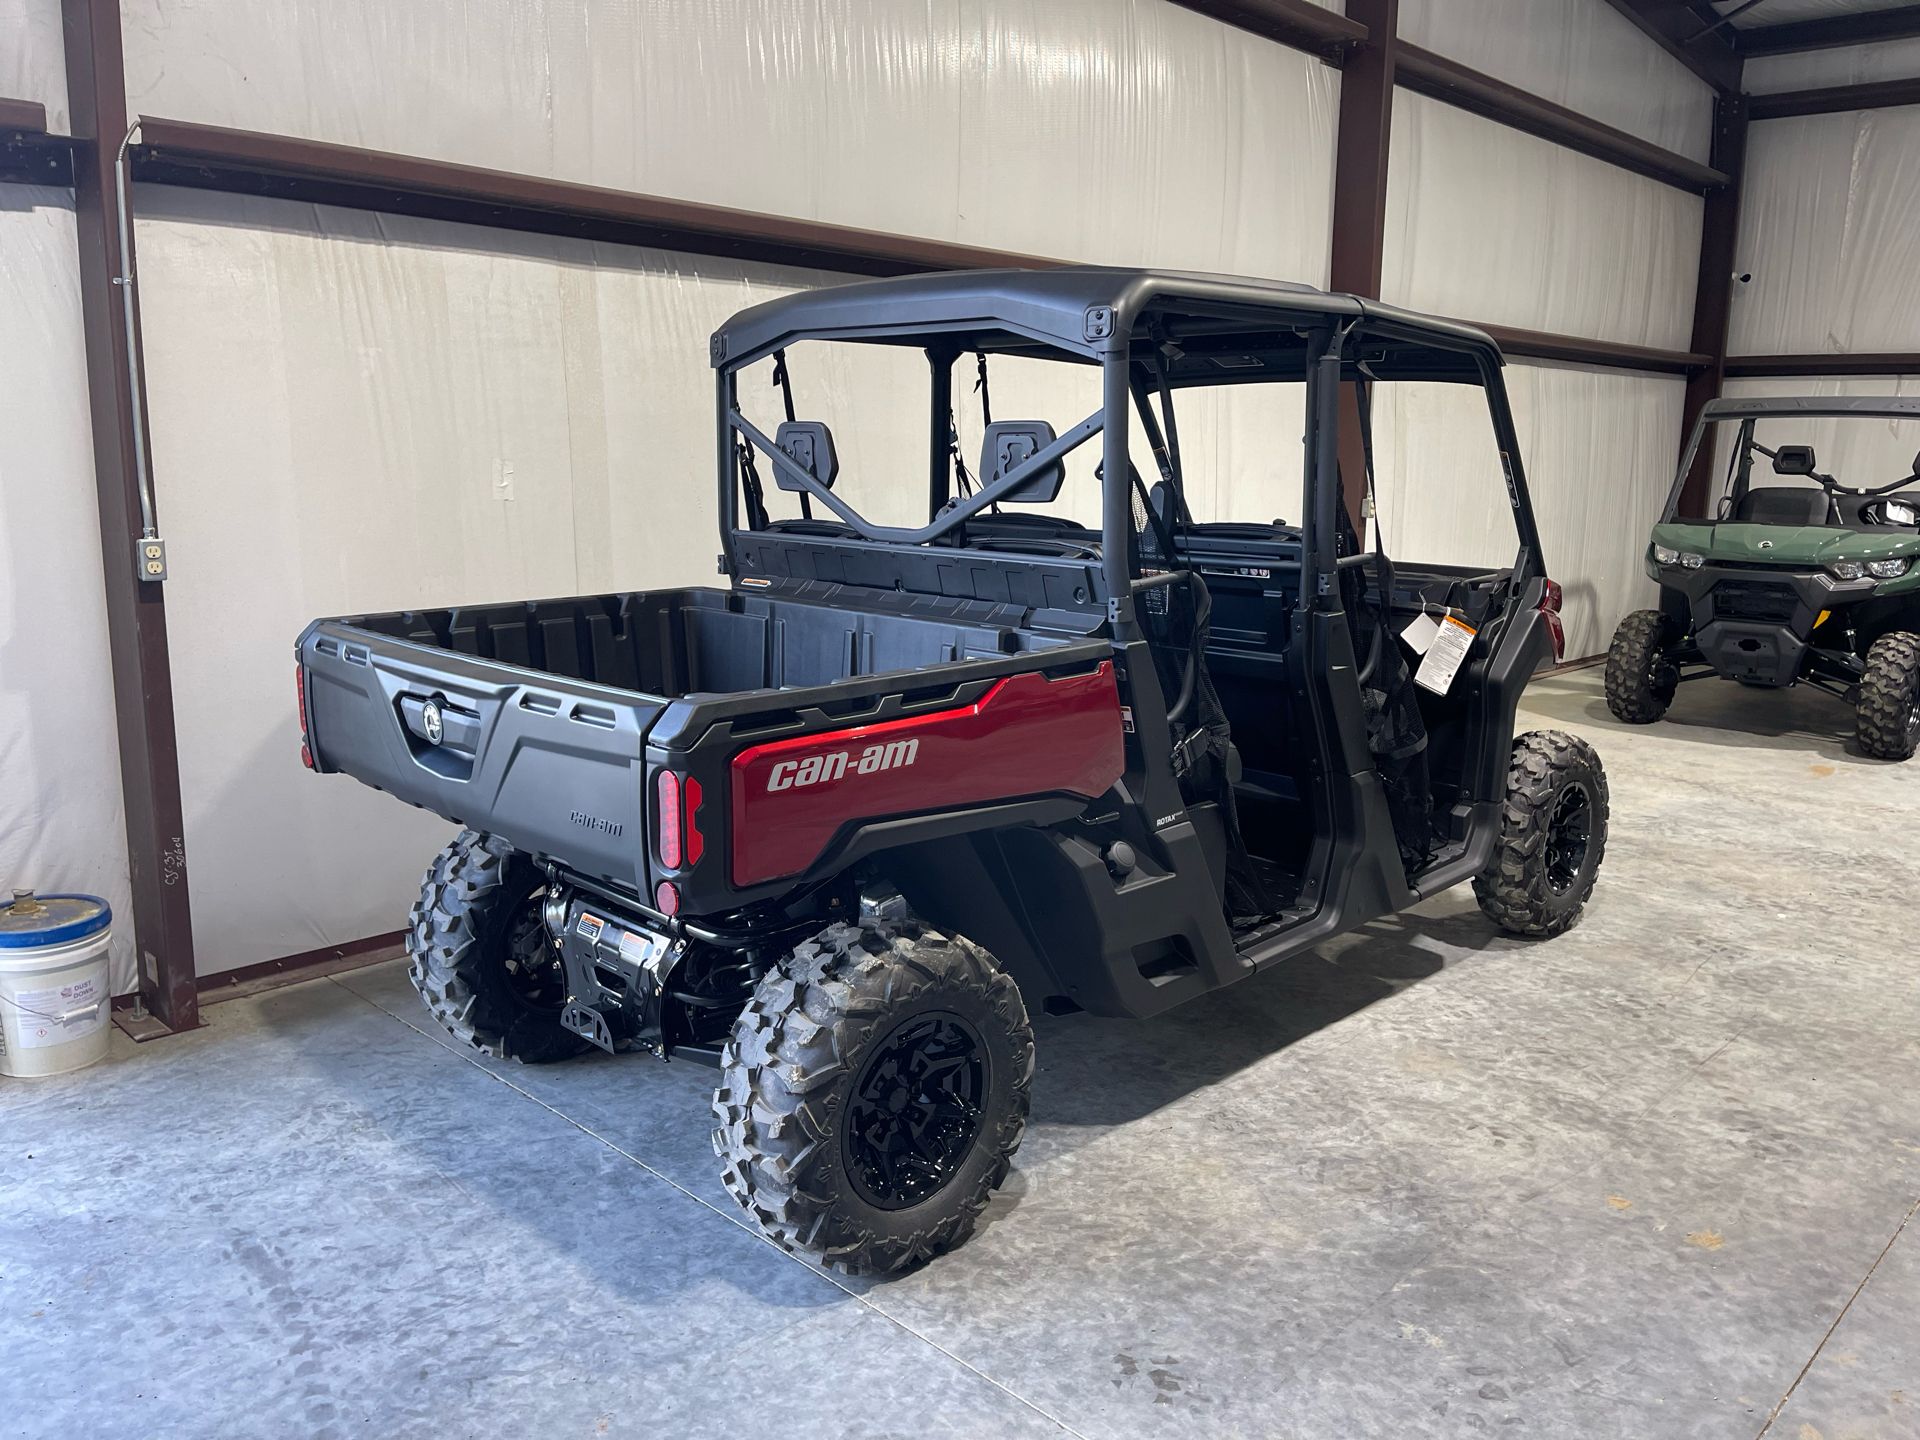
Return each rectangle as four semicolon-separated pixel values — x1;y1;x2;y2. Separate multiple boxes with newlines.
1329;0;1400;541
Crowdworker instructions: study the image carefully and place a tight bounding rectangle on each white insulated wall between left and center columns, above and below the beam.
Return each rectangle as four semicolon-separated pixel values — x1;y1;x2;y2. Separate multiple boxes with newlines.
127;0;1338;973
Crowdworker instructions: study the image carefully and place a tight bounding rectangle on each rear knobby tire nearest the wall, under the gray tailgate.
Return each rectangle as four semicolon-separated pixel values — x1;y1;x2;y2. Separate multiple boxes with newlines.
407;829;588;1066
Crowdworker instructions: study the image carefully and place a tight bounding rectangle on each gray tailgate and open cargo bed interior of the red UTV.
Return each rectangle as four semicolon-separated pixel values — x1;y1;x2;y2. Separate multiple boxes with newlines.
301;588;1066;893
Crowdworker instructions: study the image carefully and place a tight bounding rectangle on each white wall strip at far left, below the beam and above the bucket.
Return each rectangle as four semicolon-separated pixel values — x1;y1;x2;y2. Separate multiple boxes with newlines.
0;184;134;993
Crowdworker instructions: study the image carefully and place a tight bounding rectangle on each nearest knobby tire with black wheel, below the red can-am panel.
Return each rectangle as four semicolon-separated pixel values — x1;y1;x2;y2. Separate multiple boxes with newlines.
714;916;1033;1275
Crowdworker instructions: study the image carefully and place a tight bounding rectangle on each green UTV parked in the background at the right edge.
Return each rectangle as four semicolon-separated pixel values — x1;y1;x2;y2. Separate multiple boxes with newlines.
1607;396;1920;760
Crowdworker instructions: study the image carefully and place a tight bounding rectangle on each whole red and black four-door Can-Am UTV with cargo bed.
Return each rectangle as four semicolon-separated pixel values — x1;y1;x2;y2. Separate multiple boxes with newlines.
298;269;1607;1271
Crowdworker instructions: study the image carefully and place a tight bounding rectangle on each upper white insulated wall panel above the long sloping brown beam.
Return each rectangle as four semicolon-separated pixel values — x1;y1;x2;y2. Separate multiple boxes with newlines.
123;0;1338;284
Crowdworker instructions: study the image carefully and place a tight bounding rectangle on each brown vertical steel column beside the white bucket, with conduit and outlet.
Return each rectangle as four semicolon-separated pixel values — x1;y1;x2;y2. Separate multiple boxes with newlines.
61;0;200;1031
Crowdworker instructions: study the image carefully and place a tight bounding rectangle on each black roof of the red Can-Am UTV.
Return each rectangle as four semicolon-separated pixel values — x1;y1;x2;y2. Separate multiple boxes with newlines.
712;265;1496;367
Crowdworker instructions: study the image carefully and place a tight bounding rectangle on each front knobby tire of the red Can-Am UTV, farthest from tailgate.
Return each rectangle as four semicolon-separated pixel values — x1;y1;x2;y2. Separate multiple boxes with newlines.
1473;730;1607;939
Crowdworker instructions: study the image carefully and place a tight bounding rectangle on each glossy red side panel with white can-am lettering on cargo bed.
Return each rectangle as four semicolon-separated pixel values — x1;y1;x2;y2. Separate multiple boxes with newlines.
732;660;1125;885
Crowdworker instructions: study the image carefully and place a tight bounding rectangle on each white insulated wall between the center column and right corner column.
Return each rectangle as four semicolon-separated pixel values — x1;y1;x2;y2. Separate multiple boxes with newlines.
1377;14;1713;657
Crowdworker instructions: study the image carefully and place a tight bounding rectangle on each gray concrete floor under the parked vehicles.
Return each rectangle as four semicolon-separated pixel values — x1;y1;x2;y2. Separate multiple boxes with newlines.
0;670;1920;1440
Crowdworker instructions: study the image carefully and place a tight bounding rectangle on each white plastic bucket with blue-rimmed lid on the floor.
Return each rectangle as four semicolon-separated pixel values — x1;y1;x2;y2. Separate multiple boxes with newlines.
0;891;113;1077
